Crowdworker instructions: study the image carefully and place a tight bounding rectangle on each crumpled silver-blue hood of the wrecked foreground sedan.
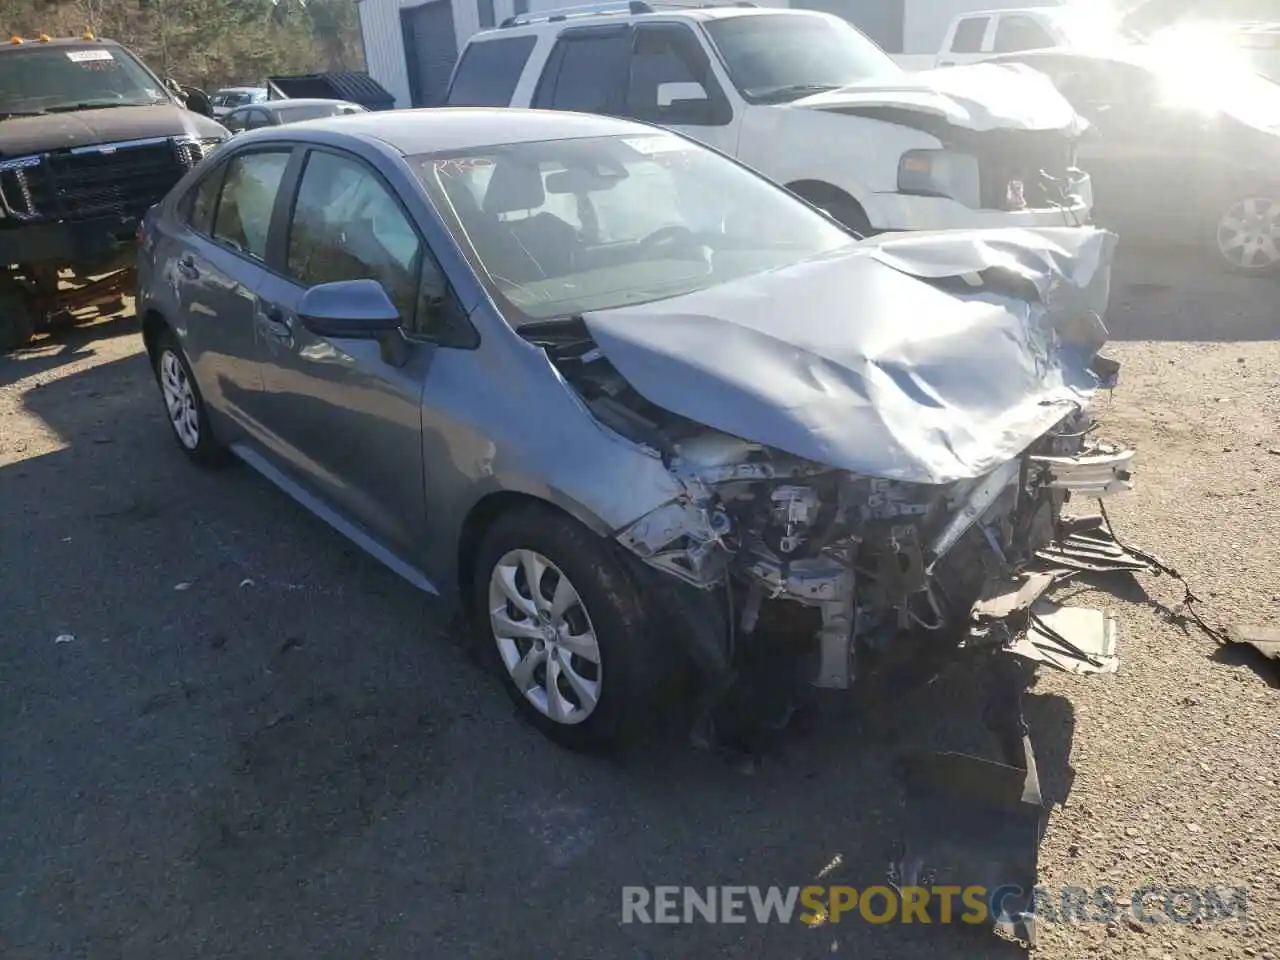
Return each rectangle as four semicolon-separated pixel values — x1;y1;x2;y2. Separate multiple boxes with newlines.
584;228;1116;484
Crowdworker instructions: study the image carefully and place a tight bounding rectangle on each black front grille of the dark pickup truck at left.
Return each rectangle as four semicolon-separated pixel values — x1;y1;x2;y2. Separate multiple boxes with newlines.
28;141;200;220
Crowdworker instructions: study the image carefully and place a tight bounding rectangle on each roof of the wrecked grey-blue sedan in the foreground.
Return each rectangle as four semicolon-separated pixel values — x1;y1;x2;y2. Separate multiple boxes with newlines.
251;106;666;156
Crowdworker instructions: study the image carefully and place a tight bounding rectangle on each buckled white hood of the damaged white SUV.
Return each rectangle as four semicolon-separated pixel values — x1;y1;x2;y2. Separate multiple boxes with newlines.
790;64;1088;136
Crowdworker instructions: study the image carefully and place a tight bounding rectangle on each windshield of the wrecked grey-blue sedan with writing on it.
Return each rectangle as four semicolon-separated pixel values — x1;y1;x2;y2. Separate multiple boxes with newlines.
415;133;856;325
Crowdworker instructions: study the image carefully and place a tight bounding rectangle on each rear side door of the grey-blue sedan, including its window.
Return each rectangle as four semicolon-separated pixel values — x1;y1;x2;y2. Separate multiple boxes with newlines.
170;147;291;433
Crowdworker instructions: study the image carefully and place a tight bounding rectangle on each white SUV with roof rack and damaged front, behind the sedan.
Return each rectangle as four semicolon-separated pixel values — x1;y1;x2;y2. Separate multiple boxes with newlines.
444;0;1093;233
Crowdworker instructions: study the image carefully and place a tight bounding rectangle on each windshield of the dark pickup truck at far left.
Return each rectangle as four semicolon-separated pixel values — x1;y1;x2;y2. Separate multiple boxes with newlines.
0;44;170;116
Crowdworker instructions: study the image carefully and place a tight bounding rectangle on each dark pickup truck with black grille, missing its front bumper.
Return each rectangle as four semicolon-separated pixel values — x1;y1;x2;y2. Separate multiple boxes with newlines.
0;35;228;349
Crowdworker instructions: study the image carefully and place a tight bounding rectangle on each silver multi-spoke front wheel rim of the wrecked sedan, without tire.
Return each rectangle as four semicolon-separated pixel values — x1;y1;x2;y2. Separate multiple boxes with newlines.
489;549;603;724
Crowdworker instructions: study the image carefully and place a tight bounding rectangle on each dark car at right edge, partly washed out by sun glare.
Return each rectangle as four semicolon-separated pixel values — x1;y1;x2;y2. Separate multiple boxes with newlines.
1000;45;1280;274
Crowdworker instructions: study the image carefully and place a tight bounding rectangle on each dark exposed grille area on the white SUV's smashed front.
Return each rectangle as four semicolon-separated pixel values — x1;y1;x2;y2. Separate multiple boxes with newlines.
974;131;1075;210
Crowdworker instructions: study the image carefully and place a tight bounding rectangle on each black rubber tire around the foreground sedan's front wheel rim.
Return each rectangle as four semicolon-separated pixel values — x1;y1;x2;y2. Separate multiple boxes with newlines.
471;507;663;753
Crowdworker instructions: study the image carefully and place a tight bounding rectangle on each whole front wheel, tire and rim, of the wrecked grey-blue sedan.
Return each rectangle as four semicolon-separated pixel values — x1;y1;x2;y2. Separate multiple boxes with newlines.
472;507;660;750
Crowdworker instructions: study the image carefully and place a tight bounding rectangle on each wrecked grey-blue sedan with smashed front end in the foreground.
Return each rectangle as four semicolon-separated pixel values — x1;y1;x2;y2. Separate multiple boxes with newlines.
137;109;1133;768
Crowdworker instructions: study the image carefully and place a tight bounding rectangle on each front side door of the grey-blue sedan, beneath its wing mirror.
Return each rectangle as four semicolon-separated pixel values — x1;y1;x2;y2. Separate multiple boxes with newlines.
256;150;443;559
